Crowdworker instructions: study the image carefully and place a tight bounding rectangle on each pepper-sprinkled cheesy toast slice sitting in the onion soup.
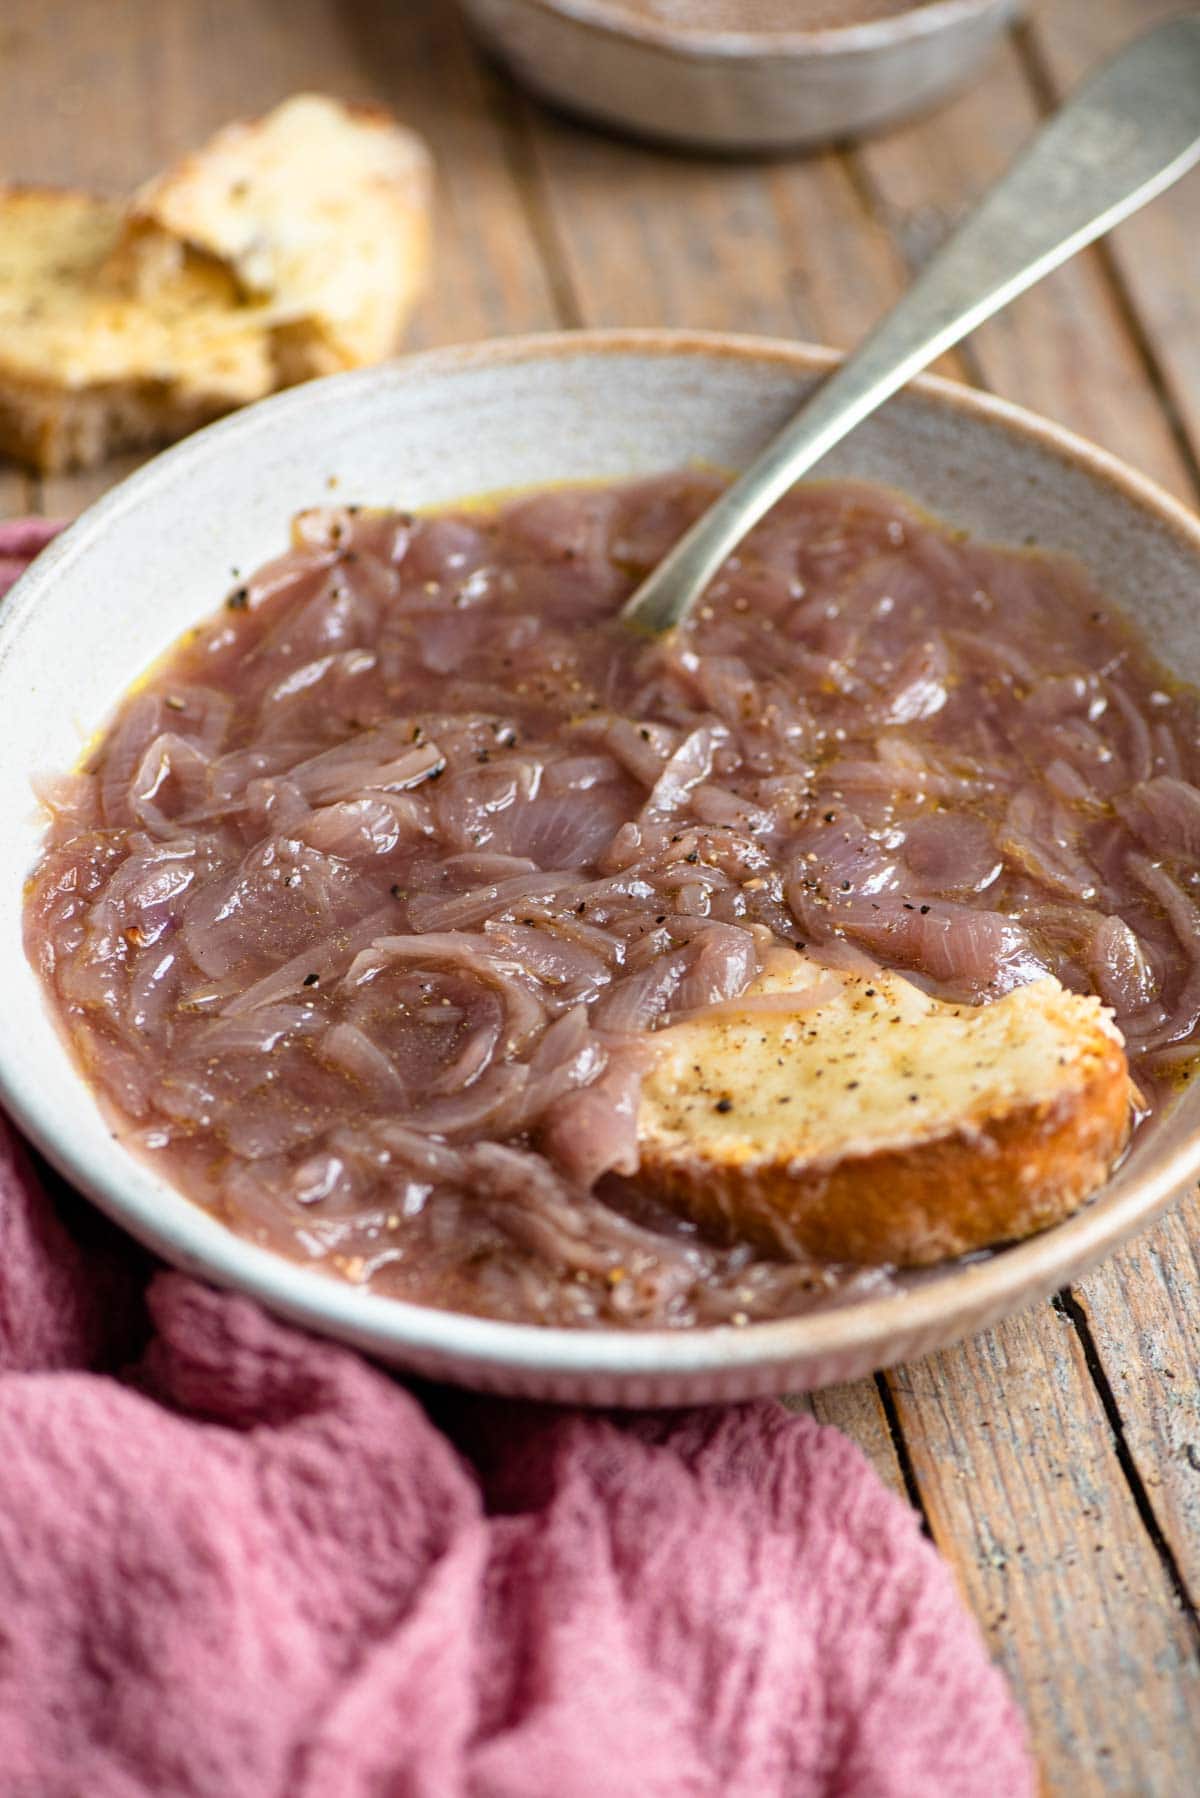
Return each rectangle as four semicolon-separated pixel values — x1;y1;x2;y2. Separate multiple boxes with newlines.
639;957;1133;1266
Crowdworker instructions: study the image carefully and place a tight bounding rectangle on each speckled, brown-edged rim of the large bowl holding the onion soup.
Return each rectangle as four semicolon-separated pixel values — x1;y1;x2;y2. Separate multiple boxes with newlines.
0;329;1200;1402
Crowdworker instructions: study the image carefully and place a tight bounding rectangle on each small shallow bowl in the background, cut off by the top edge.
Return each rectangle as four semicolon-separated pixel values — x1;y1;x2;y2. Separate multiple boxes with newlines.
461;0;1018;151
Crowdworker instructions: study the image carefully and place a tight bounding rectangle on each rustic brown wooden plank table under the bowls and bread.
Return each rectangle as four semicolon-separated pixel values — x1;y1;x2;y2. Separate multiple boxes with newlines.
0;0;1200;1798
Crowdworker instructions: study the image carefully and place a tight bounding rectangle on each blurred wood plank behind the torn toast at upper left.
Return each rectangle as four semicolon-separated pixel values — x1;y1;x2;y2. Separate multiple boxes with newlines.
0;0;558;514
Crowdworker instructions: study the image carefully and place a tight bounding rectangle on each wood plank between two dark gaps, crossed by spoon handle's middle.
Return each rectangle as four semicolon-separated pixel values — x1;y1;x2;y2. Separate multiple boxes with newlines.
858;28;1195;494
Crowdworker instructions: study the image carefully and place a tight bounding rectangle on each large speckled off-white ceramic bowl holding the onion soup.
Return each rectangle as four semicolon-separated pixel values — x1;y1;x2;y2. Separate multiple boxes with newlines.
0;331;1200;1404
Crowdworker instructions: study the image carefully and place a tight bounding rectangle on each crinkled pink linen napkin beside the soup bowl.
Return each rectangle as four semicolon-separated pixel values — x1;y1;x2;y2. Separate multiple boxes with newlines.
0;525;1036;1798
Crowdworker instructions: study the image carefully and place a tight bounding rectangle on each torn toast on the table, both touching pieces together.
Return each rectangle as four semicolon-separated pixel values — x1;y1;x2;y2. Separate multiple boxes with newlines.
0;95;430;473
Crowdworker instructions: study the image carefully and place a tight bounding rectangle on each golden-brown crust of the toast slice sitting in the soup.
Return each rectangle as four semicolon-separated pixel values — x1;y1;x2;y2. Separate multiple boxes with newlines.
639;976;1133;1268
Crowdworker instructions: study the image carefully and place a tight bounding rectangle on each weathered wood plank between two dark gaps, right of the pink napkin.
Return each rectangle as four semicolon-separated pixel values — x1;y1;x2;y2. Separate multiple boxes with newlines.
889;1307;1200;1798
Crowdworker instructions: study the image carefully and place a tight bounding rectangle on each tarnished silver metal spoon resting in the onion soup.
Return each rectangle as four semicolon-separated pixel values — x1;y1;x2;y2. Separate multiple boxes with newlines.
622;13;1200;633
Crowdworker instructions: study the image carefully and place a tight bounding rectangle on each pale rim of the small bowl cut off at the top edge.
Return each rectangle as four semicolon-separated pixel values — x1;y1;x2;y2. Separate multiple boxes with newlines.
524;0;1020;59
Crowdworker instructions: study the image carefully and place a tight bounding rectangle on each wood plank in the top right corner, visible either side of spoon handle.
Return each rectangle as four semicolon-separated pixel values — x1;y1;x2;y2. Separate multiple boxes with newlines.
1024;0;1200;467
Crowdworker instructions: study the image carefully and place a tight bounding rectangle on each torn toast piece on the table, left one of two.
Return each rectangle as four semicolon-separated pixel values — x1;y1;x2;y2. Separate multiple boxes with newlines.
0;187;275;473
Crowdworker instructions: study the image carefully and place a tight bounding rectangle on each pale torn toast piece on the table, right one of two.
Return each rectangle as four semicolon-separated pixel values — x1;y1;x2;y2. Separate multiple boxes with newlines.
113;93;432;381
